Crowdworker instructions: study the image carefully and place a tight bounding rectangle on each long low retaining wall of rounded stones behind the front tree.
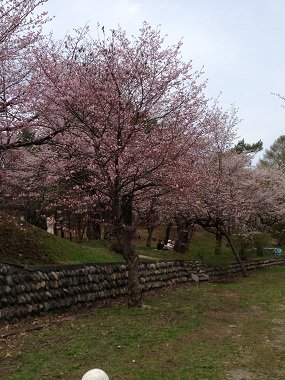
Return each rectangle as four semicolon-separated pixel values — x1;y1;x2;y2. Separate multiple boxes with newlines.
0;258;285;323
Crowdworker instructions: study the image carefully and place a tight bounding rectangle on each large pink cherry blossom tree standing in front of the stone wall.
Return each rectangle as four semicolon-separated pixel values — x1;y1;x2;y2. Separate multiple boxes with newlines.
19;24;207;306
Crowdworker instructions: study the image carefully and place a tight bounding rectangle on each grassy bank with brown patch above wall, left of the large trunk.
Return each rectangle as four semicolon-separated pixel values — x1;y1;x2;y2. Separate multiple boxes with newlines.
0;213;122;265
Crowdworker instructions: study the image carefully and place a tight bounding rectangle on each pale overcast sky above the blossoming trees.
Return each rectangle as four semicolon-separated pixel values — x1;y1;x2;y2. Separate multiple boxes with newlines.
41;0;285;160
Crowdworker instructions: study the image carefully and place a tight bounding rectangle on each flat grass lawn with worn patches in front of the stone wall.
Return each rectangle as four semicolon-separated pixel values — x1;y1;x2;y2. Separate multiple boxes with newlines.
0;267;285;380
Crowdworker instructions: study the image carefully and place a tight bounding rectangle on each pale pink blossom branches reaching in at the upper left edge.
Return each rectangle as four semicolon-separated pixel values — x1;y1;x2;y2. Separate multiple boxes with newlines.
0;0;66;159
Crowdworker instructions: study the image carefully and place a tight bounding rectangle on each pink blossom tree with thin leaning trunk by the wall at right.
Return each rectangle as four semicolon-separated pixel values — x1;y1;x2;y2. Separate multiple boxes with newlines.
168;106;285;275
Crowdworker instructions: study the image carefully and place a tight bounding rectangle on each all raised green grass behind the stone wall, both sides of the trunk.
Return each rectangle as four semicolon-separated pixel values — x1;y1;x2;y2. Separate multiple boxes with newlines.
0;213;280;266
